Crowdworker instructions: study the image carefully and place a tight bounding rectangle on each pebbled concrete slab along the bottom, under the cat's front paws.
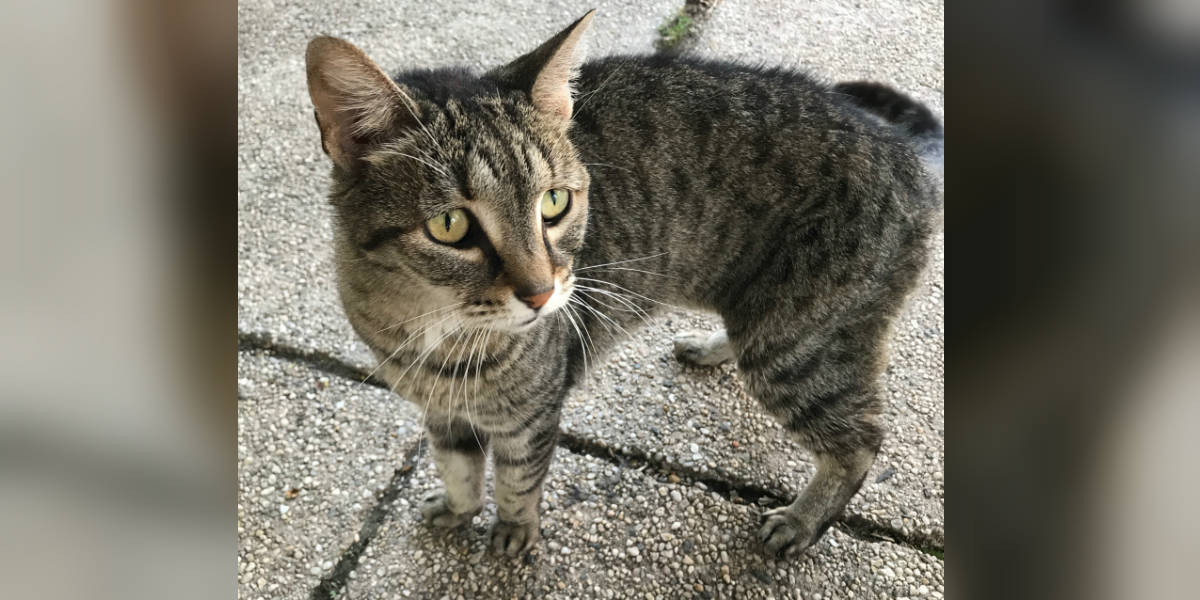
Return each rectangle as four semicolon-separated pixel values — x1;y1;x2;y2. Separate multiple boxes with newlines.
360;451;944;599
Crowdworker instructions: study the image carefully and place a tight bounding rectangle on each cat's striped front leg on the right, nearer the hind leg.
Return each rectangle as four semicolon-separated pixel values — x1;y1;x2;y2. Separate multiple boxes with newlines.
491;410;558;557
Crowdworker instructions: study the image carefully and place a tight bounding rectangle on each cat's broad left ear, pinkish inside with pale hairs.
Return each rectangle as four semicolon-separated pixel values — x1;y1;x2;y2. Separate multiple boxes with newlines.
305;36;418;170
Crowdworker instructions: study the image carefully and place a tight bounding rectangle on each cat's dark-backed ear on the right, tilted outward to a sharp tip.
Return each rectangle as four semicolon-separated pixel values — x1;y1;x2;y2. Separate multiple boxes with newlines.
490;8;595;122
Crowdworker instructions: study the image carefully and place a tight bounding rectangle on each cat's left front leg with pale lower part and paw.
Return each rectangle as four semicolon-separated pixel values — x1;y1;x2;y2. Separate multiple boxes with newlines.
421;421;487;528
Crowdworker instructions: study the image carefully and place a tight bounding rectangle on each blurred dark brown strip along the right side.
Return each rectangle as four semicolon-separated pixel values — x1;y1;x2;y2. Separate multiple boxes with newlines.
946;0;1200;599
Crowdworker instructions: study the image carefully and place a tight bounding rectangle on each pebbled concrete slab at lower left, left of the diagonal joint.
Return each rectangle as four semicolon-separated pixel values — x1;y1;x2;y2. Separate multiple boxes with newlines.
238;353;420;599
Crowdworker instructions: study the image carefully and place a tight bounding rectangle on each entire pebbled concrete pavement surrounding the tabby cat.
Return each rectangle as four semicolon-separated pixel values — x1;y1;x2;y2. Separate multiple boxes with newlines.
238;0;953;598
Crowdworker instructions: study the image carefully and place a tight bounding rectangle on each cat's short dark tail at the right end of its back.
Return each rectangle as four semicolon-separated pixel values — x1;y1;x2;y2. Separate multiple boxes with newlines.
833;82;946;184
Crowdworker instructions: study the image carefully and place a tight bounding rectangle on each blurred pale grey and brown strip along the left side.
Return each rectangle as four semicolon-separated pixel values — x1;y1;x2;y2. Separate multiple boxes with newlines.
0;0;236;599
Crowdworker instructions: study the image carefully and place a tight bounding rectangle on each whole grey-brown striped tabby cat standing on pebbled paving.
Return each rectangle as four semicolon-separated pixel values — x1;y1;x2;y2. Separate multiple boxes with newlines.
306;12;942;556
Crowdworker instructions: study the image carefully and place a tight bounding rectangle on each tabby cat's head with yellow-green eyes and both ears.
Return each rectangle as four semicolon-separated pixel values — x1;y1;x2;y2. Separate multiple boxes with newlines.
306;12;592;331
